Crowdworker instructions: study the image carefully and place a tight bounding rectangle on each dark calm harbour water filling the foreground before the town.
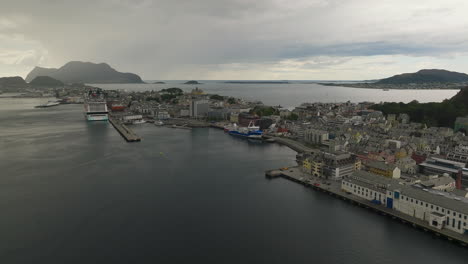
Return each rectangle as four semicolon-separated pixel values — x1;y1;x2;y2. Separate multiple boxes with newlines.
0;99;468;264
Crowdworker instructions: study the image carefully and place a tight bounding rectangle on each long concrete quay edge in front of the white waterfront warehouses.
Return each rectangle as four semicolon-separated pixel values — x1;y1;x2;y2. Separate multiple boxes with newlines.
265;167;468;248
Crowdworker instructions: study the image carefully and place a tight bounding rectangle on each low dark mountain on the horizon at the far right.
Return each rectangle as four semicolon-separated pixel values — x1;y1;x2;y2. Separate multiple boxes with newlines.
377;69;468;84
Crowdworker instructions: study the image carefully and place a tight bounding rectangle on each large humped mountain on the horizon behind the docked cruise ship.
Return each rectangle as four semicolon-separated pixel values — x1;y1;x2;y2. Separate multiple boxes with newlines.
26;61;143;83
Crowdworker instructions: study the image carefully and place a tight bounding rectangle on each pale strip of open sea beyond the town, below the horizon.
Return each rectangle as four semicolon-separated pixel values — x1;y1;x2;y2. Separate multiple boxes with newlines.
89;81;458;108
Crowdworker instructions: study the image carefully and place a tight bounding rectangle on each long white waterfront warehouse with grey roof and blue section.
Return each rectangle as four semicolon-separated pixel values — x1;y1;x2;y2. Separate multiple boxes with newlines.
341;171;468;234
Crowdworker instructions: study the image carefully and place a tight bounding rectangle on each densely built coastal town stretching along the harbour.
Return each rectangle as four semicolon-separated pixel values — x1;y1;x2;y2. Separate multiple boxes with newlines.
2;75;468;245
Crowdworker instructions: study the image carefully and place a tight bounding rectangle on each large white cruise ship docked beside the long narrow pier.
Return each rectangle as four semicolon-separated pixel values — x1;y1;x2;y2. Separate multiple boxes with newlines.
84;89;109;121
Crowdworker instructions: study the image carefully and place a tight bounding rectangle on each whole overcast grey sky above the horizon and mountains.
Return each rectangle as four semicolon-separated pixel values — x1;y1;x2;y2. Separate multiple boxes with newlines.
0;0;468;80
